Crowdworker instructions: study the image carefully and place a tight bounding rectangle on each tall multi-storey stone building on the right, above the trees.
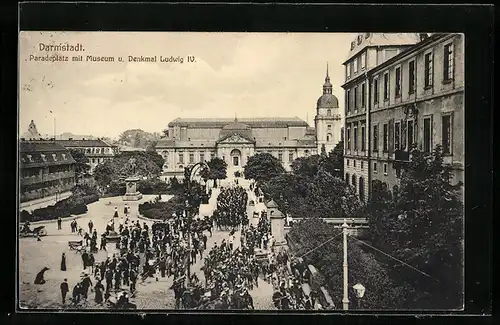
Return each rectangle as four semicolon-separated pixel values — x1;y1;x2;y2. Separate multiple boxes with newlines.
342;33;464;201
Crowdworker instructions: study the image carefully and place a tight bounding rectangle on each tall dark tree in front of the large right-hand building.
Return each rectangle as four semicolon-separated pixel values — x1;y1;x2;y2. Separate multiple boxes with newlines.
370;146;463;309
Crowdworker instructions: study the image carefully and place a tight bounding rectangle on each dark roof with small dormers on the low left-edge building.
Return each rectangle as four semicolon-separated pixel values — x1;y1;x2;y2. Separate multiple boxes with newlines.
19;141;75;168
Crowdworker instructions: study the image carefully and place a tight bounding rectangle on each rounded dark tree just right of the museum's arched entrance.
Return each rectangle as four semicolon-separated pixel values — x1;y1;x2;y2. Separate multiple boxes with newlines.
244;153;285;183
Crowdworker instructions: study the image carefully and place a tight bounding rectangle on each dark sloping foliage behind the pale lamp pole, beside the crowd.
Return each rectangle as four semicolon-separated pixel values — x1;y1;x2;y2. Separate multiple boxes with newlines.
288;219;408;309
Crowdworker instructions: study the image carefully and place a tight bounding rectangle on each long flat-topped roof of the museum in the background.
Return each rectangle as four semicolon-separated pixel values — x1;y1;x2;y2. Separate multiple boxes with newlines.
168;117;307;128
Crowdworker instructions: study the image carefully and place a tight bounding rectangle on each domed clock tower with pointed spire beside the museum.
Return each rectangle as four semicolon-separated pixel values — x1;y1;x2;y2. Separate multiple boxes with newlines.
314;63;342;153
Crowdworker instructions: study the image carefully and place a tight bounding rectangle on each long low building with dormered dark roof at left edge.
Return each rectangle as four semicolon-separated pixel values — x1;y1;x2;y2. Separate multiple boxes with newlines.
19;140;75;203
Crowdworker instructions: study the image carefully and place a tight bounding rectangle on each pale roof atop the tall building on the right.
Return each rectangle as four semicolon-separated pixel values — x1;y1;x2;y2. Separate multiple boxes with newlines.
343;33;420;64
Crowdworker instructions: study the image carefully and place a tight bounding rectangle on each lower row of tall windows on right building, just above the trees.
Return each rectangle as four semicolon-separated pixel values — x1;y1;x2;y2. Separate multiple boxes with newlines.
346;114;453;155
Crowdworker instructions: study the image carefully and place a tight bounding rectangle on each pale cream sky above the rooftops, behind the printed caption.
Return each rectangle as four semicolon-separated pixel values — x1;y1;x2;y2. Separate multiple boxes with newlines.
19;32;356;138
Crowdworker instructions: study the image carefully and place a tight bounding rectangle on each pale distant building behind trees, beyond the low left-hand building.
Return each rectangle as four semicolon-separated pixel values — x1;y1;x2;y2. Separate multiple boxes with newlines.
56;138;117;174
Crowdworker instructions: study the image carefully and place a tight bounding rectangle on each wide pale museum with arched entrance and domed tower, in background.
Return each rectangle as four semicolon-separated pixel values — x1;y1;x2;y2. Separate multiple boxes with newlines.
156;69;342;178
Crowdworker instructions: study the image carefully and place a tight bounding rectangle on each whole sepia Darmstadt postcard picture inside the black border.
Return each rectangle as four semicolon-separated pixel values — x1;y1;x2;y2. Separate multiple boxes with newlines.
16;31;465;313
